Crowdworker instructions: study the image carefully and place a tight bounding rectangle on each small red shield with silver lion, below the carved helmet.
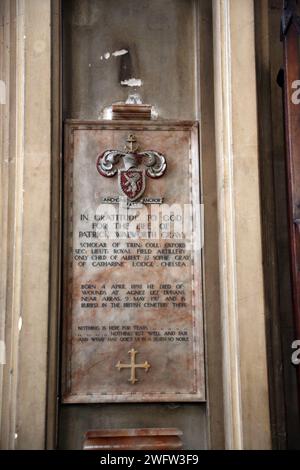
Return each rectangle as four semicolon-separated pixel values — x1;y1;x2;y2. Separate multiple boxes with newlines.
119;168;146;201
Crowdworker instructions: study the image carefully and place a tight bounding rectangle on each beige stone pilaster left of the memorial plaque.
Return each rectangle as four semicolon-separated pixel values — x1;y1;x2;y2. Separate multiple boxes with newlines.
0;0;51;449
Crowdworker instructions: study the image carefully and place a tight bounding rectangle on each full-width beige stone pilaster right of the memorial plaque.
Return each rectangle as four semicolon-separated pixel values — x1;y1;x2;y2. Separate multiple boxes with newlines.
213;0;271;449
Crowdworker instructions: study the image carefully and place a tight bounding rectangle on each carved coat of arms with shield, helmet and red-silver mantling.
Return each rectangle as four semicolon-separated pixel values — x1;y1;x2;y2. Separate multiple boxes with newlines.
97;134;167;202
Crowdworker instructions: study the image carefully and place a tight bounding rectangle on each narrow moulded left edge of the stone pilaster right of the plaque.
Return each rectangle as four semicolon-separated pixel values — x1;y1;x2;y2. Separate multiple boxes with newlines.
213;0;243;449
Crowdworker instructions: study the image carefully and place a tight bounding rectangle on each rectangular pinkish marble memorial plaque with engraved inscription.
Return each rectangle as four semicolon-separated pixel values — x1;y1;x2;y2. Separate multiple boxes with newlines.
62;121;205;403
